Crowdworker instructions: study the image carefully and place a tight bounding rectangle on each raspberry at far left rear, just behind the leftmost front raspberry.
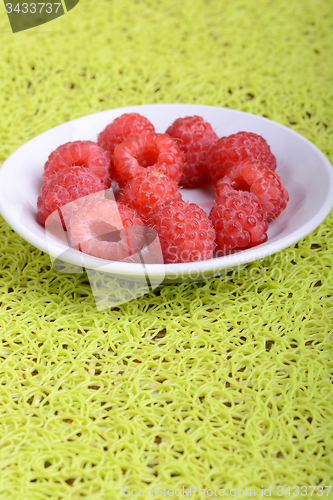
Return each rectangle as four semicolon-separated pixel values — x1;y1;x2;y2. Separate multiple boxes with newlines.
44;141;112;187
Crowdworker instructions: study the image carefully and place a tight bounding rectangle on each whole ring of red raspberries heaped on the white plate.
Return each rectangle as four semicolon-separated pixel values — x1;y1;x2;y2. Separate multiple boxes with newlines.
37;113;289;264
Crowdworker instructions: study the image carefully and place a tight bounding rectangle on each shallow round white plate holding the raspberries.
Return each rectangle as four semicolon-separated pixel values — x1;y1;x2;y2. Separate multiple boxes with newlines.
0;104;333;283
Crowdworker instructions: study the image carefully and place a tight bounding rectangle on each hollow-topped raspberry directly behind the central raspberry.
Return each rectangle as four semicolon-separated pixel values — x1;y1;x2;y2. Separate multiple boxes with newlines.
113;132;183;186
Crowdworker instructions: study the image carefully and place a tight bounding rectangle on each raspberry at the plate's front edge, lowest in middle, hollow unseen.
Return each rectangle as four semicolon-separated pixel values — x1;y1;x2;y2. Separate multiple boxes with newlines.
148;201;215;264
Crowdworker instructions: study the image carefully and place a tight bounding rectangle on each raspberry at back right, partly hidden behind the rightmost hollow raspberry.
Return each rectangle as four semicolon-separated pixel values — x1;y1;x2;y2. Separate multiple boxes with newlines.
208;132;276;184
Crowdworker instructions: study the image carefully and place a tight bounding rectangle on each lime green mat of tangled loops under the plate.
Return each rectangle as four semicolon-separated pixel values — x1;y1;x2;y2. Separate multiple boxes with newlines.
0;0;333;500
